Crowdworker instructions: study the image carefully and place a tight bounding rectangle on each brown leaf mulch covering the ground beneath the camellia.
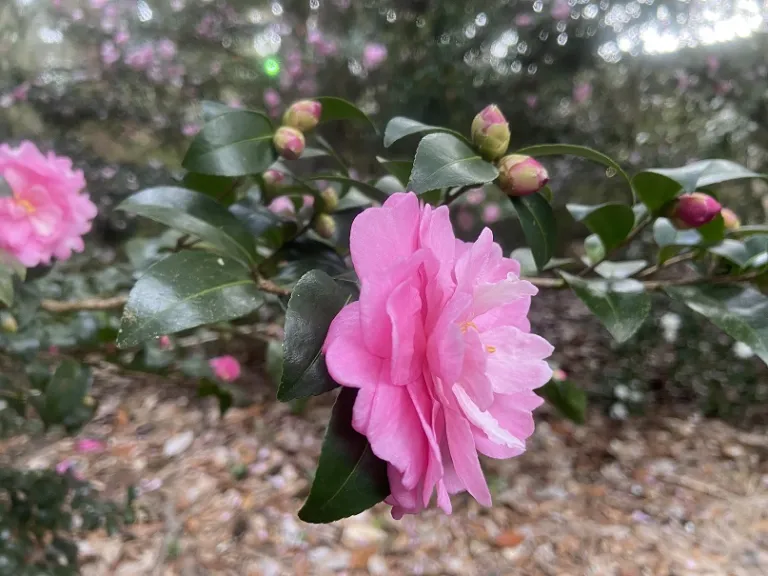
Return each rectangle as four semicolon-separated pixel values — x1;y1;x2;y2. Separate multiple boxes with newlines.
5;367;768;576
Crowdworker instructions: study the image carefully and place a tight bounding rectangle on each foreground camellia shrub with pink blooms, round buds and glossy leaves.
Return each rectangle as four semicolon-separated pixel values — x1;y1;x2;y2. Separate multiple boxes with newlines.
0;97;768;536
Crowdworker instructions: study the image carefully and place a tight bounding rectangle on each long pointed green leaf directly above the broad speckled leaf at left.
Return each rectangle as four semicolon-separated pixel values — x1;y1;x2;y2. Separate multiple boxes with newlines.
117;186;259;264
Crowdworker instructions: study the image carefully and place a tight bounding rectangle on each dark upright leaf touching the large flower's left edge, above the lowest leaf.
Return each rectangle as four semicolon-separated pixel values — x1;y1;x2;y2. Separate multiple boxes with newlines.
277;270;350;402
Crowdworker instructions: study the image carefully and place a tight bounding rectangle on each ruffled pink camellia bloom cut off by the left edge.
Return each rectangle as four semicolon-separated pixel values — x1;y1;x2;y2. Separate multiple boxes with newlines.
0;142;96;268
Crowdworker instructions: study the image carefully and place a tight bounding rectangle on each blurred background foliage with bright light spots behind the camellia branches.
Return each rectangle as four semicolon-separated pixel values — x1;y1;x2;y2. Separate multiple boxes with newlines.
0;0;768;418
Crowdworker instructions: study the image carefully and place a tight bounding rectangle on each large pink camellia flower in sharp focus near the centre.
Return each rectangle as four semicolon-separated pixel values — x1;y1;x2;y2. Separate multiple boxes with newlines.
323;193;552;518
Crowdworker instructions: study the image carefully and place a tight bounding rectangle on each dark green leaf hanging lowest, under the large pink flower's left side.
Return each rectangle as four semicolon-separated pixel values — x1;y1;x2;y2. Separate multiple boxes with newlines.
299;388;390;523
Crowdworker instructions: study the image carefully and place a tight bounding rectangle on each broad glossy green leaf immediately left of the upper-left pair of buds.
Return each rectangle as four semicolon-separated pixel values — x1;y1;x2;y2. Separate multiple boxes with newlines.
182;110;277;176
